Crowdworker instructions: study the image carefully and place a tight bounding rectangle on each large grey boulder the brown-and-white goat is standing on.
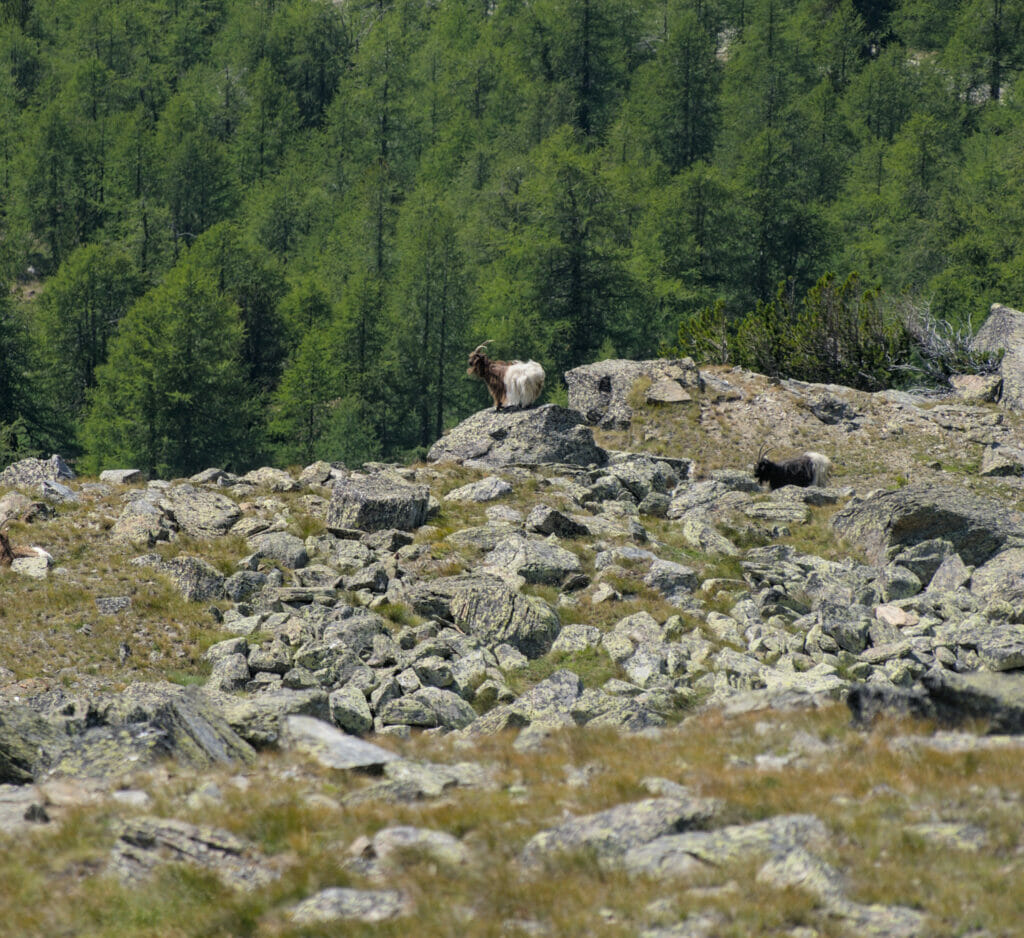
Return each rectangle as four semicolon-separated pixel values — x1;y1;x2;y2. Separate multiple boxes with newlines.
427;403;608;467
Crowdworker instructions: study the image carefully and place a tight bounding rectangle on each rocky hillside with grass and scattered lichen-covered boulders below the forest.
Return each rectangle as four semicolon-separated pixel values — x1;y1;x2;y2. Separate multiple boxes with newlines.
6;333;1024;938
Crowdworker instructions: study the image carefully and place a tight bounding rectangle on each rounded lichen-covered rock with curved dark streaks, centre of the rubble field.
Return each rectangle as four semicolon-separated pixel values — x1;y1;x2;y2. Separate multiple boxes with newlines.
450;577;561;658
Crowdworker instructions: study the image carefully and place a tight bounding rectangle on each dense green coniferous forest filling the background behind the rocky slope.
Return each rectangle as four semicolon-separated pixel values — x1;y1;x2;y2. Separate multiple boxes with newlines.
0;0;1024;476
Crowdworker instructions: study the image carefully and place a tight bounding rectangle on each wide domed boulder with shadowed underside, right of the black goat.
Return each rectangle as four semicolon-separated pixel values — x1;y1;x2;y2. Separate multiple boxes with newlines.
833;484;1024;564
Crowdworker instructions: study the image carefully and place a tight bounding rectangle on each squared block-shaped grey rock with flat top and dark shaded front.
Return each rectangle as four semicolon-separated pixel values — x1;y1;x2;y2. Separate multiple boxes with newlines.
327;472;430;531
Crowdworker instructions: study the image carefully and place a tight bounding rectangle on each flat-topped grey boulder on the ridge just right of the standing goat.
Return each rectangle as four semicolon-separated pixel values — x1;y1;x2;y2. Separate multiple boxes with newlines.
565;358;700;429
